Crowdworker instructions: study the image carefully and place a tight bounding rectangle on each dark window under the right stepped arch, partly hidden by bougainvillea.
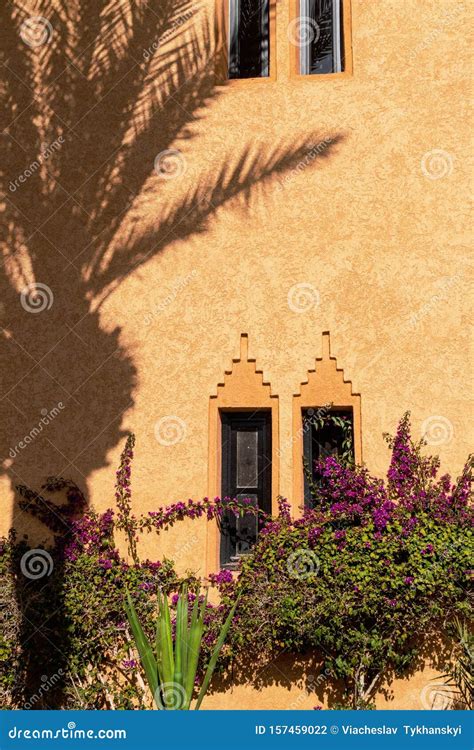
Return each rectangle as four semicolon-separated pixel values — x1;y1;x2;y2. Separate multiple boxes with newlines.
303;407;354;506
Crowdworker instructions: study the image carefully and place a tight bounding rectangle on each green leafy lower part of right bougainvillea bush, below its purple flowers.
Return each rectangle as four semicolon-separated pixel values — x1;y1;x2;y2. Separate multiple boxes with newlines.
224;513;474;708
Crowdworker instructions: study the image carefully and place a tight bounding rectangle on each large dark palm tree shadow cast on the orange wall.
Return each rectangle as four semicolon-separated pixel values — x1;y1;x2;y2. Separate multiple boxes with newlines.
0;0;341;704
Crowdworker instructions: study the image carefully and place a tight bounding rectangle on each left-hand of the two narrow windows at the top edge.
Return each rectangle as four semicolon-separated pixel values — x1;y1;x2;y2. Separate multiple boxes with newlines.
229;0;270;78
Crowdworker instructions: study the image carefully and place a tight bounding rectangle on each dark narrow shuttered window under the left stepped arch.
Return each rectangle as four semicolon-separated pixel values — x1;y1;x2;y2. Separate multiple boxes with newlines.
220;411;272;566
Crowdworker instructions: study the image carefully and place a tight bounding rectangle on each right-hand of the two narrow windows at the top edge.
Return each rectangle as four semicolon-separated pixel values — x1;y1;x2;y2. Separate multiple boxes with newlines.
293;0;344;75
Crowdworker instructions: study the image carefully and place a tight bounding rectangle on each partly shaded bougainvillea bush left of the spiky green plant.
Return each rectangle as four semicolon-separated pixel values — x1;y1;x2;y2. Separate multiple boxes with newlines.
0;511;183;709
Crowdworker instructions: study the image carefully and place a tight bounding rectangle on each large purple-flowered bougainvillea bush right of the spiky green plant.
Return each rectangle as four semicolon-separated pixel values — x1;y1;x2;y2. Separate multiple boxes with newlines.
212;415;474;708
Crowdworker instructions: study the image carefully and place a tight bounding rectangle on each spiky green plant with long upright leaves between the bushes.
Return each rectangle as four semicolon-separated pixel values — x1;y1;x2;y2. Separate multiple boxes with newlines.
125;586;238;711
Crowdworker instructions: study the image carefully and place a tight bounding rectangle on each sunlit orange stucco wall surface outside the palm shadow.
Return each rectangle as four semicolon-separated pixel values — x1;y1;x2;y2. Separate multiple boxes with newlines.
91;0;471;561
